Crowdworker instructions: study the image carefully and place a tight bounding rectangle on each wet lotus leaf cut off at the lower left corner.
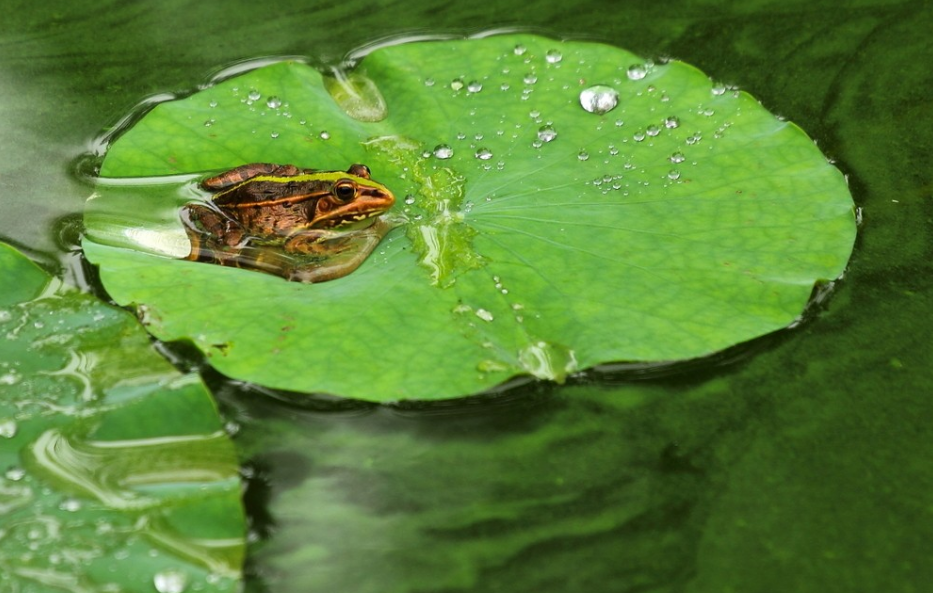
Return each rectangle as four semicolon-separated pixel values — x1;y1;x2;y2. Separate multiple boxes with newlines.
0;244;244;593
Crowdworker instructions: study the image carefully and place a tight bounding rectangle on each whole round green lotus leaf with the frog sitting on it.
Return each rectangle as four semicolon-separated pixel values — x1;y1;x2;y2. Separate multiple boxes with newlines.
85;35;855;401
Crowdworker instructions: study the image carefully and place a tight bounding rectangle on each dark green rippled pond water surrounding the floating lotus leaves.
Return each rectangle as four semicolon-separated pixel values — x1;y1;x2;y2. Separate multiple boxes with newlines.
0;0;933;593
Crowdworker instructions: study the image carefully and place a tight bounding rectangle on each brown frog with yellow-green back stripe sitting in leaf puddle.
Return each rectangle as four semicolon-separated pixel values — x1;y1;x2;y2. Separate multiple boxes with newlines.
181;163;399;283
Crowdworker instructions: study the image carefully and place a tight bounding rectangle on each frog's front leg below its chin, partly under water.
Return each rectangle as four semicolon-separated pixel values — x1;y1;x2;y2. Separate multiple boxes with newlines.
284;218;396;283
